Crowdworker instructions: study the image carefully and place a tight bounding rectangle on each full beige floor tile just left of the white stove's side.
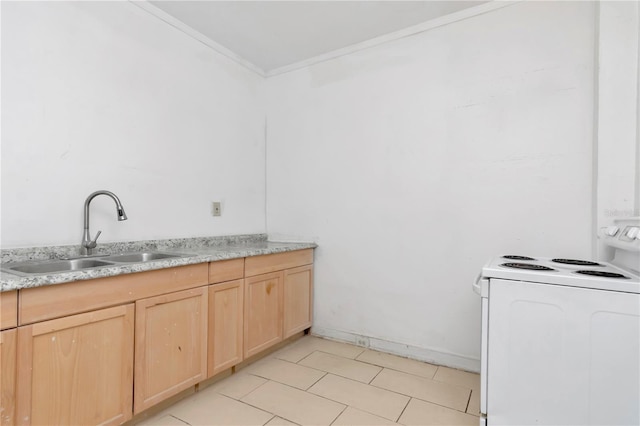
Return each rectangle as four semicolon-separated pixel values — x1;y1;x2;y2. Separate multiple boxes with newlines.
371;368;471;411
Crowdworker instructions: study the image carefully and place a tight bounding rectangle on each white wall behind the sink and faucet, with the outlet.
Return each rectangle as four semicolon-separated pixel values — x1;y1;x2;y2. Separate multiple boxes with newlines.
1;1;265;248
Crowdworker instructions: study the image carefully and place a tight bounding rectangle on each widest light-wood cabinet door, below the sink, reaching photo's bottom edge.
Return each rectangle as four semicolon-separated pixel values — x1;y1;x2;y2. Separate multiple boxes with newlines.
16;304;134;425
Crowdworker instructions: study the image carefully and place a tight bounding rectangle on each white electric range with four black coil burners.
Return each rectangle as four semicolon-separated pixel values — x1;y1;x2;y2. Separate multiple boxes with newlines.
474;218;640;426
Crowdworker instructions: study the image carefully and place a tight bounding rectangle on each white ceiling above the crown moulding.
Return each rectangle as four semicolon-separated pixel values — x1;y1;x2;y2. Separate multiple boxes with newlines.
148;0;486;74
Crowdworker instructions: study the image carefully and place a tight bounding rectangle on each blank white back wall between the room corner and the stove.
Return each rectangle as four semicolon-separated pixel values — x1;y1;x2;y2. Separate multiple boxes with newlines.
267;2;595;369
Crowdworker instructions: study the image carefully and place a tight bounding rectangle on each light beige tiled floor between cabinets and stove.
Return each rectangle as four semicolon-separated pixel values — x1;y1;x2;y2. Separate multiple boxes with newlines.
139;336;480;426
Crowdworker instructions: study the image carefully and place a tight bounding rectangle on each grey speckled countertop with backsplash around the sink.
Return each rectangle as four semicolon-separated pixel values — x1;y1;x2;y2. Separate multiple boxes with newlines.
0;234;317;291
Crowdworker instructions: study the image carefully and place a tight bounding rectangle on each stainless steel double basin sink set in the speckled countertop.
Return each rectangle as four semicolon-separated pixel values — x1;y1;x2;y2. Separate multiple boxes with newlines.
2;251;192;276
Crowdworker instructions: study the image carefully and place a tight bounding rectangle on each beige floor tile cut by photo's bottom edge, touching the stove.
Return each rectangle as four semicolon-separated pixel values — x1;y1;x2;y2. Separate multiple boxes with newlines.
398;399;478;426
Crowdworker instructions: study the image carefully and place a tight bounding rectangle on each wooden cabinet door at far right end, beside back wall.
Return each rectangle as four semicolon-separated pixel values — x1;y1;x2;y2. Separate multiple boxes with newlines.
284;265;313;339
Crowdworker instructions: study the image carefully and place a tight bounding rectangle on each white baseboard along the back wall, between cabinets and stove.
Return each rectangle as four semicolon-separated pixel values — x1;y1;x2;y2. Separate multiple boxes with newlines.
311;326;480;373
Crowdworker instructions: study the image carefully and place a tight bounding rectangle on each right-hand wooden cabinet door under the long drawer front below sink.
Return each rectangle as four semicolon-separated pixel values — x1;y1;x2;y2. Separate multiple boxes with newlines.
134;287;208;414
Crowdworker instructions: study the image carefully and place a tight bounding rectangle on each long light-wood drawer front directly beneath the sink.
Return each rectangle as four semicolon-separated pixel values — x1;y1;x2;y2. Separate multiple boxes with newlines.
19;263;209;325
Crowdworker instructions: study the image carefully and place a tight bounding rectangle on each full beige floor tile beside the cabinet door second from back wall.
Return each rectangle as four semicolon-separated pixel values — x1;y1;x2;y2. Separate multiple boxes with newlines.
246;358;325;390
